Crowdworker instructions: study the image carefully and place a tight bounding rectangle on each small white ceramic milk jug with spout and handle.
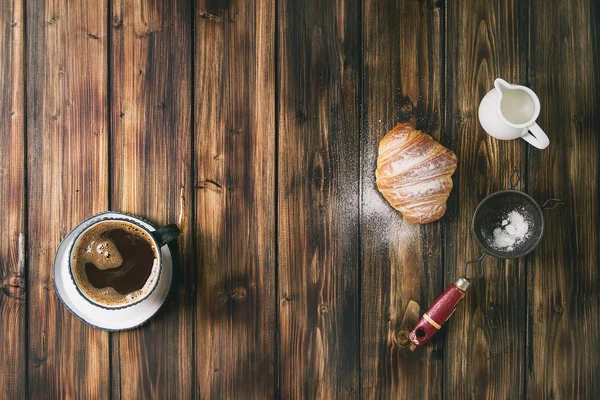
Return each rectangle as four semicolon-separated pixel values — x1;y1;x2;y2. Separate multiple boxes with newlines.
479;78;550;149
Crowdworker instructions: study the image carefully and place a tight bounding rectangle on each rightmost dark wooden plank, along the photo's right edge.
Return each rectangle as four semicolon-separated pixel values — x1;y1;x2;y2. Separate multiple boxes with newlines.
526;0;600;399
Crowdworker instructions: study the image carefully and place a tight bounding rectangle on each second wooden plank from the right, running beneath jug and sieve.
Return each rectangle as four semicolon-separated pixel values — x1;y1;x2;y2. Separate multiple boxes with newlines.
444;1;527;398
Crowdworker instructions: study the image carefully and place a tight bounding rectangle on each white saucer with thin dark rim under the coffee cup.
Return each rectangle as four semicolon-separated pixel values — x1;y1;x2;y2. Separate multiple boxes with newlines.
52;211;173;331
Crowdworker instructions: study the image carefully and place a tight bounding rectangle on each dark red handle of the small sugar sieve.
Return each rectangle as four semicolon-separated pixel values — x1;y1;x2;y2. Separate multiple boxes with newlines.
408;278;469;346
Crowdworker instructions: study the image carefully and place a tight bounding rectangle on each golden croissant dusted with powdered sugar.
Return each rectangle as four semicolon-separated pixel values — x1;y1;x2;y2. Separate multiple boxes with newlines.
375;124;458;224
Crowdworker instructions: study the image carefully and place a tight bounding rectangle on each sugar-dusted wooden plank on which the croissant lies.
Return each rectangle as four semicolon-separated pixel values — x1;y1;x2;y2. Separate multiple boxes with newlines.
361;0;446;399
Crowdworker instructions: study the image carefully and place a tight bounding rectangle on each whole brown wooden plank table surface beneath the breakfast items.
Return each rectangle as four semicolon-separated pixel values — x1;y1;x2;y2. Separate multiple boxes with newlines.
0;0;600;399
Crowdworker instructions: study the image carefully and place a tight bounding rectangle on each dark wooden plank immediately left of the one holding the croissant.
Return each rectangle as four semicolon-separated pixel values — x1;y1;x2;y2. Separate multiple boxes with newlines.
278;0;360;399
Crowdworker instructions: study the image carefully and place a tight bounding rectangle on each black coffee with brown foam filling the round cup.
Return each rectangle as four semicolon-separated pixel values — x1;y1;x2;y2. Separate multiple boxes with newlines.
72;221;158;306
